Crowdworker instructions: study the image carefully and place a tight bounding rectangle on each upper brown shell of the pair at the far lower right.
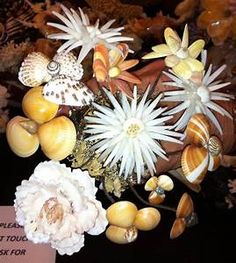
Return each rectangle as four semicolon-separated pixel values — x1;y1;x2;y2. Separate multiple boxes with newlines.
176;193;193;218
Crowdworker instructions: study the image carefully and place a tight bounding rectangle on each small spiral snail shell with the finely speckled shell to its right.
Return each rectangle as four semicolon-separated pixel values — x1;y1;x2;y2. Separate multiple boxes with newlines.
51;52;84;80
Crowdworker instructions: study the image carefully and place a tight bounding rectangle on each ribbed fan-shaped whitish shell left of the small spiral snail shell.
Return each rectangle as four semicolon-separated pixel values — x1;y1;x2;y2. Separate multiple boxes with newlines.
18;52;51;87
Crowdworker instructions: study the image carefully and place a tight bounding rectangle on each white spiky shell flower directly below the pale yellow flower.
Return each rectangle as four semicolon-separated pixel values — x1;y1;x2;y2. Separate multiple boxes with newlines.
162;51;234;134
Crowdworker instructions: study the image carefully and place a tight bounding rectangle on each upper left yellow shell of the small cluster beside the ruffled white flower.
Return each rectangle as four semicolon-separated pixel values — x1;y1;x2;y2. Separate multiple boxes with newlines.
107;201;138;227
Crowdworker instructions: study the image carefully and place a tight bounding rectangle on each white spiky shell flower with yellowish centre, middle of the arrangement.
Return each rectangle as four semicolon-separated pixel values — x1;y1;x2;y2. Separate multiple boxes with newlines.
85;87;182;183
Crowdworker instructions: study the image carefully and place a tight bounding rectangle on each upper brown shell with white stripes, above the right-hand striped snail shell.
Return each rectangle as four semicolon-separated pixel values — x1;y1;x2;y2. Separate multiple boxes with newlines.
186;113;210;146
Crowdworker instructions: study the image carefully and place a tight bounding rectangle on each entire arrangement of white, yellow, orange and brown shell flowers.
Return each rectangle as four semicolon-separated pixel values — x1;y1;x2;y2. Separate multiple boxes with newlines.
6;5;234;255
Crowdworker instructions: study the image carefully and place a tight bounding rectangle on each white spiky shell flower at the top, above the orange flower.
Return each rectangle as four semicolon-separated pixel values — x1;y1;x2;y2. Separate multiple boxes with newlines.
47;5;133;63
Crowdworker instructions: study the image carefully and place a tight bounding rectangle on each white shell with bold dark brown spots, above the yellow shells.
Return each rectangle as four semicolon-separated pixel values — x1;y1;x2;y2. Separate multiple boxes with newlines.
43;75;94;107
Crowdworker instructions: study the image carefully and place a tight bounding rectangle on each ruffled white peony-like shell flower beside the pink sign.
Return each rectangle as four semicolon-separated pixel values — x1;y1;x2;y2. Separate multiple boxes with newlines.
15;161;107;255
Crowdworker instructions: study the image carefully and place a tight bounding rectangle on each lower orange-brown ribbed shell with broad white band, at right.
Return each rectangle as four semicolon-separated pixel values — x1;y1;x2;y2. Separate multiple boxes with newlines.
181;145;209;184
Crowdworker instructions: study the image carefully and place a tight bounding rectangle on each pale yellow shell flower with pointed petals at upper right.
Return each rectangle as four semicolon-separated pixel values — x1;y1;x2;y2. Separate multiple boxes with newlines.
143;25;205;79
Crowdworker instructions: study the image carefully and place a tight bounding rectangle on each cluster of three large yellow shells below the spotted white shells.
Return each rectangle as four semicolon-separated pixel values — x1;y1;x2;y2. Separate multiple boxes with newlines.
6;86;76;161
